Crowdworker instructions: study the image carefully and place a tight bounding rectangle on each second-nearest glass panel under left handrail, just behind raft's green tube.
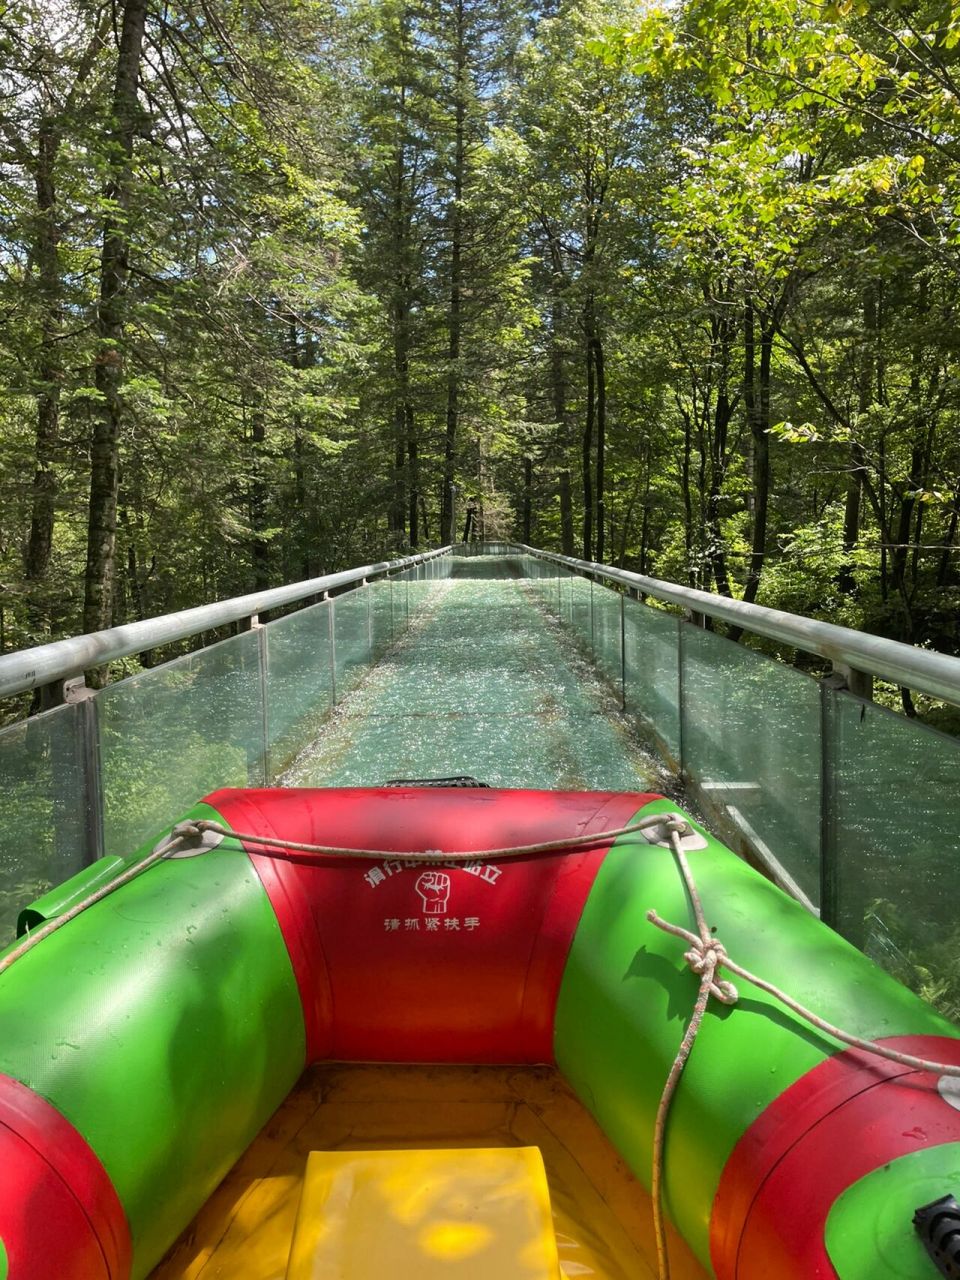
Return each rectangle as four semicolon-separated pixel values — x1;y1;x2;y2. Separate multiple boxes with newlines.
96;631;265;855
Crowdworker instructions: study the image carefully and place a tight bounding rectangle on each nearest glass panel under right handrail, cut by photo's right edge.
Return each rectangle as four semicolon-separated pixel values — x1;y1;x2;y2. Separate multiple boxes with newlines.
826;691;960;1019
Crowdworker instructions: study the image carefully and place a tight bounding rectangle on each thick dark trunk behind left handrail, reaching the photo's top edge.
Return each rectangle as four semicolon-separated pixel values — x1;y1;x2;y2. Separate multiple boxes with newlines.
83;0;147;631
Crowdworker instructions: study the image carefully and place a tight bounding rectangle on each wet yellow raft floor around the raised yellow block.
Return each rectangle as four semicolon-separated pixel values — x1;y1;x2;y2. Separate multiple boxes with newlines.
152;1065;707;1280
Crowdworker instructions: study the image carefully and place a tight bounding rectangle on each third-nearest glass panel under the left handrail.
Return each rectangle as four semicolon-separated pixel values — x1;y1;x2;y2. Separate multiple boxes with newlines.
266;600;332;781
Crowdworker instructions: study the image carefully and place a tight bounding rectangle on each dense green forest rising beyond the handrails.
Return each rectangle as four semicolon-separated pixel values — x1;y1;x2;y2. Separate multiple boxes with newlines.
0;0;960;714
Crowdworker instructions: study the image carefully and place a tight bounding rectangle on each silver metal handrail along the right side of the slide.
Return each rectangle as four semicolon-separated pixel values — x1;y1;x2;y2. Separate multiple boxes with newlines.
471;543;960;705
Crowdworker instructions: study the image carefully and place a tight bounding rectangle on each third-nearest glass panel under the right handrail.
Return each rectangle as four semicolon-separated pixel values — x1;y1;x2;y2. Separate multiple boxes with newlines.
623;596;680;762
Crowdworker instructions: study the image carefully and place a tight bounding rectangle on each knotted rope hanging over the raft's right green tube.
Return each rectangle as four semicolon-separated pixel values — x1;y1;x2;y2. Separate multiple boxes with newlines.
646;819;960;1280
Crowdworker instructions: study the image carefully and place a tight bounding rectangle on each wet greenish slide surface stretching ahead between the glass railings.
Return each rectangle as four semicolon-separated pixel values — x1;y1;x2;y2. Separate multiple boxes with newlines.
280;577;662;791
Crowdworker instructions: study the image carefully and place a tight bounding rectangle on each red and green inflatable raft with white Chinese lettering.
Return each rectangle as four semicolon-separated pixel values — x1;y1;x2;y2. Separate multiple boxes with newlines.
0;786;960;1280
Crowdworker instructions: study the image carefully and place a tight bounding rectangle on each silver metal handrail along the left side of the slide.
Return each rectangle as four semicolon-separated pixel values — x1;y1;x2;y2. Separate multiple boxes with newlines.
0;547;451;698
